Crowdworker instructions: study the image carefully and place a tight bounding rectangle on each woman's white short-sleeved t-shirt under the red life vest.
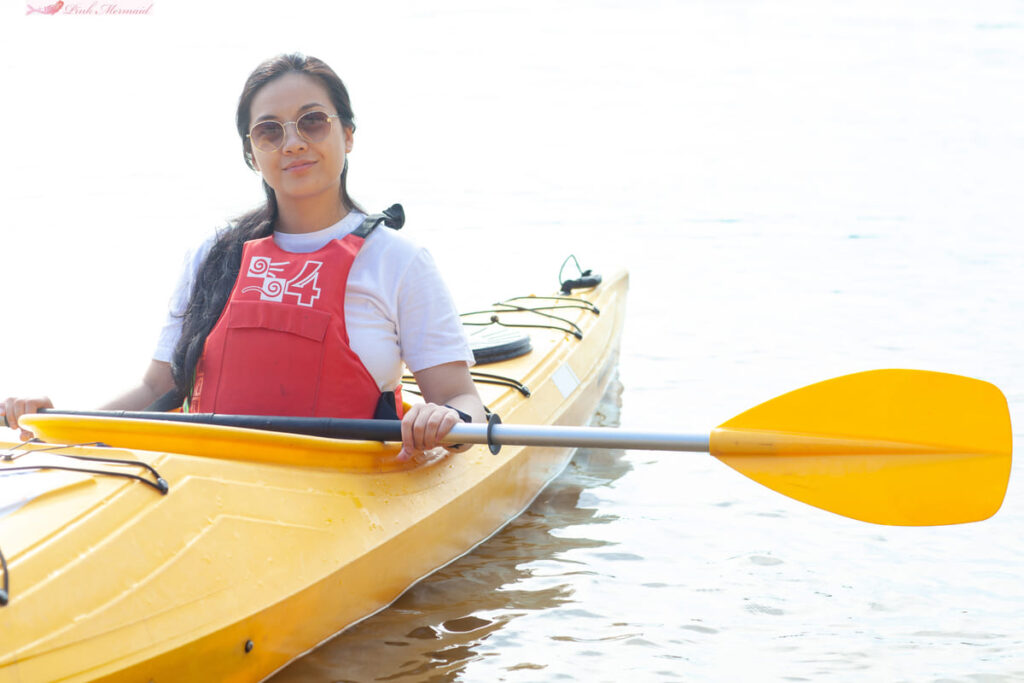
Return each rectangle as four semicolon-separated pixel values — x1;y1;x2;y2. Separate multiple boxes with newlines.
153;211;473;391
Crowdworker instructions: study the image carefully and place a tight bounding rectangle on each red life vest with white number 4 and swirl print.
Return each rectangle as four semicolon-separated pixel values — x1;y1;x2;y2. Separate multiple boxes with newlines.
188;229;401;419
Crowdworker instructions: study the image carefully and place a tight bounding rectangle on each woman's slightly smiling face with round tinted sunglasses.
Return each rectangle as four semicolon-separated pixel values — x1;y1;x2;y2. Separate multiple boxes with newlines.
249;73;352;204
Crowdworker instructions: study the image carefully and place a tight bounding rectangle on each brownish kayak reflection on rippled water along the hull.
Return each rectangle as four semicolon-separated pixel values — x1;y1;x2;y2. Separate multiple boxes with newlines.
271;380;631;683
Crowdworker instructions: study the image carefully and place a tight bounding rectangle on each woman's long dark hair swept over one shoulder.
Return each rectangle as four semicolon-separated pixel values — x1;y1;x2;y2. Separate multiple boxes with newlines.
171;53;366;397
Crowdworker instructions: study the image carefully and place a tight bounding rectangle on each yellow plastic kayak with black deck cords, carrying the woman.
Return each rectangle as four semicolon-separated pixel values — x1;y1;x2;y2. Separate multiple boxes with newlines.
0;272;628;683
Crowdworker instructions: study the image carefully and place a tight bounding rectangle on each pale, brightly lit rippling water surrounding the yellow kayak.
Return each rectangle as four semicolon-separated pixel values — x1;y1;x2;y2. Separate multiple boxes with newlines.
0;0;1024;681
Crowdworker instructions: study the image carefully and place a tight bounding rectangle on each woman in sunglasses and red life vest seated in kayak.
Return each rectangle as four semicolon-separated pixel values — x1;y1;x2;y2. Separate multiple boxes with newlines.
2;54;484;460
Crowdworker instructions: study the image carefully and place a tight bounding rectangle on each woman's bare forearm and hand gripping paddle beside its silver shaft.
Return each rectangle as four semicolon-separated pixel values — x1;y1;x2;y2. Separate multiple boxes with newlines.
398;360;486;460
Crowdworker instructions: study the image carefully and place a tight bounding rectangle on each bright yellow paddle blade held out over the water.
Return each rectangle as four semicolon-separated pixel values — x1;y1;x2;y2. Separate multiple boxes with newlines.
711;370;1013;526
